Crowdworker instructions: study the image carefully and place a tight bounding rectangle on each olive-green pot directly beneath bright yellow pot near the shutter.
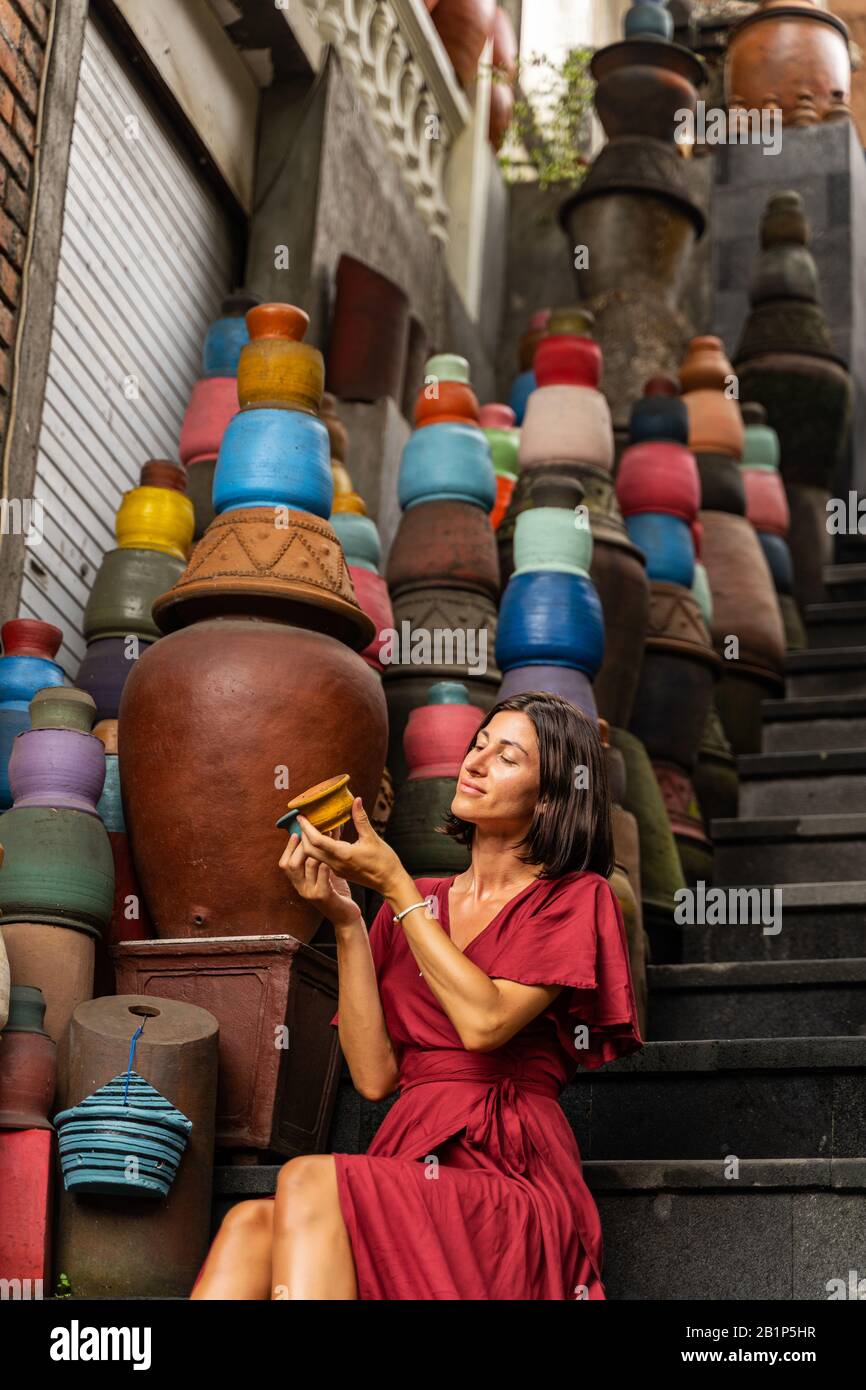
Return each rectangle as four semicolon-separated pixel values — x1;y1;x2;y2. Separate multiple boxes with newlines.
85;549;186;642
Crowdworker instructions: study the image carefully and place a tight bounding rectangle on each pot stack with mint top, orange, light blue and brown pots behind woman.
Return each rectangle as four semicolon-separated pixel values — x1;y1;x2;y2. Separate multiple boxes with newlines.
379;353;499;788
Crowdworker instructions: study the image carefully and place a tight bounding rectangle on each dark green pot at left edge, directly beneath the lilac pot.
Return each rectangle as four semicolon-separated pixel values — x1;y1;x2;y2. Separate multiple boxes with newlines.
0;806;114;935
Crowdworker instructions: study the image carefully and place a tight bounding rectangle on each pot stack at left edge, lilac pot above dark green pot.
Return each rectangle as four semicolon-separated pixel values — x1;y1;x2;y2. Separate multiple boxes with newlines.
0;687;114;1061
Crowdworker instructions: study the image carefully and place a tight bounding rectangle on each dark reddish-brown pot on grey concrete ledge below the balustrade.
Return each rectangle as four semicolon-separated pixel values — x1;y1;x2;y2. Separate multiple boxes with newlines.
327;256;409;402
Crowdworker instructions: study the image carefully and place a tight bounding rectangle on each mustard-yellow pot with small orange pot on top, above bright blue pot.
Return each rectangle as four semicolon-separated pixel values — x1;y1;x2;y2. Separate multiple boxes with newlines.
238;304;325;416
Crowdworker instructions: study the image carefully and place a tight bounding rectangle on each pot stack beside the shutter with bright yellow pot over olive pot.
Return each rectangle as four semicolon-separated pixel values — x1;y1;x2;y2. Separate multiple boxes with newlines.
76;459;195;719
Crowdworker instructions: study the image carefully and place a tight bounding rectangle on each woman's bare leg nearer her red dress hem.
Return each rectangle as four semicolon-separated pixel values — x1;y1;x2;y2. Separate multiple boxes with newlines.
271;1154;357;1300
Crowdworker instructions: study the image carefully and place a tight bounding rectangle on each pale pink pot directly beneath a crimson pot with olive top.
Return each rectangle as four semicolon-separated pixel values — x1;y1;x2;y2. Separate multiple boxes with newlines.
520;386;613;473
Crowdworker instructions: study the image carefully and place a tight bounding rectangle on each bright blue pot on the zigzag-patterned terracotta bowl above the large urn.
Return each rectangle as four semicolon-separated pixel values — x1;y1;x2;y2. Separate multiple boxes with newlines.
214;407;334;521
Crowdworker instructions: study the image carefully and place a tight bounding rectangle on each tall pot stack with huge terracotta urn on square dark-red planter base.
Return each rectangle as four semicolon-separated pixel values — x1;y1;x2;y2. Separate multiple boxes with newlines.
114;304;388;1155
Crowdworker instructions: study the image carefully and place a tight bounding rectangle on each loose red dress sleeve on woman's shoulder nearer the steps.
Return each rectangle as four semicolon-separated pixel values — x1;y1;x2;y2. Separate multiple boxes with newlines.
491;874;644;1069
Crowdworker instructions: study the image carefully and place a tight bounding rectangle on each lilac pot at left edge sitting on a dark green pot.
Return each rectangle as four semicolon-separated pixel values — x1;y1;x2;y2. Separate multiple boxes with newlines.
8;728;106;816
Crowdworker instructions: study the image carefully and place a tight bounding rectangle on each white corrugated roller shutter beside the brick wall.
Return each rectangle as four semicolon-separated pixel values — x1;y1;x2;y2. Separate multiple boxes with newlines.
19;13;234;678
